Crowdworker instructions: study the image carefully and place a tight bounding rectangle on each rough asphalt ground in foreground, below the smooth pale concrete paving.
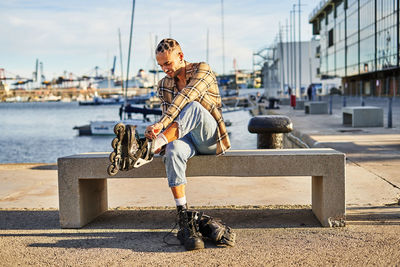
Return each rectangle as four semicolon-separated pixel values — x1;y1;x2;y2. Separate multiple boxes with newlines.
0;207;400;266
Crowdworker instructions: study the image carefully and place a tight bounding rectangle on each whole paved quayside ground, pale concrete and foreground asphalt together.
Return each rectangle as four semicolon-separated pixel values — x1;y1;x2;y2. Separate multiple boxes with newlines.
0;96;400;266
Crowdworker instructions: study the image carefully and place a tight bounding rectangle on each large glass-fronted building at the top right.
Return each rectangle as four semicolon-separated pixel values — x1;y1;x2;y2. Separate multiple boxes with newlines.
309;0;400;96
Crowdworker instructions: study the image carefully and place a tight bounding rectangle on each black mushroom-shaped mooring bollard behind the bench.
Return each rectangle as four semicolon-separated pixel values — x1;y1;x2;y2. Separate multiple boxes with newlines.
247;115;293;149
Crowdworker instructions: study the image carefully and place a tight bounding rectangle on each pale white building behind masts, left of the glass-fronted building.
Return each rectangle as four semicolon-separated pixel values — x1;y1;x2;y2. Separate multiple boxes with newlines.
259;38;321;98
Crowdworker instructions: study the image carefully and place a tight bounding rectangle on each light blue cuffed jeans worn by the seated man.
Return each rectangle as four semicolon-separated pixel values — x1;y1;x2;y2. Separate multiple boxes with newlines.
163;101;217;187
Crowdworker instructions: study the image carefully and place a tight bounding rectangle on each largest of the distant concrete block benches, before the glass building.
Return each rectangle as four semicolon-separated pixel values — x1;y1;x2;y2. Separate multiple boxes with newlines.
342;106;383;127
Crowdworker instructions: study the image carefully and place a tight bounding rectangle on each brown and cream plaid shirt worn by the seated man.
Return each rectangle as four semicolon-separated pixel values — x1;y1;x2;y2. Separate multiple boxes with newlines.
157;62;231;155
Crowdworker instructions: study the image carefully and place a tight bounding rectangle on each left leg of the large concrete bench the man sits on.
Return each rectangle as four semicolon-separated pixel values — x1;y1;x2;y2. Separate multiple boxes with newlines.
58;177;108;228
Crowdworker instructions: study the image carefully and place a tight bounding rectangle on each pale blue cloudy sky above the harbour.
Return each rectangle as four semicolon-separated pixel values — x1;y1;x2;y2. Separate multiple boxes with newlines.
0;0;319;79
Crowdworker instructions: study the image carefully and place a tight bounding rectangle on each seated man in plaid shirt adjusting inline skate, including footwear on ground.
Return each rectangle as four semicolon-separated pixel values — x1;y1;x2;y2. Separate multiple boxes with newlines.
108;39;235;250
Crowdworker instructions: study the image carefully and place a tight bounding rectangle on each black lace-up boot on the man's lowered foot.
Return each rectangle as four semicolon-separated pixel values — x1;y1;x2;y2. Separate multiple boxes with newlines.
177;208;204;250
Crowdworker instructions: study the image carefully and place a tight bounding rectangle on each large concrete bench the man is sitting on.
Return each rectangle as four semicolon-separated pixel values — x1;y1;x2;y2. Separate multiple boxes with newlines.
58;148;346;228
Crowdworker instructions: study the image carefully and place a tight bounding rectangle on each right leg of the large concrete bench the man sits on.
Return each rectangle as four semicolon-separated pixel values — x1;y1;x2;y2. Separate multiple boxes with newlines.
312;175;346;227
